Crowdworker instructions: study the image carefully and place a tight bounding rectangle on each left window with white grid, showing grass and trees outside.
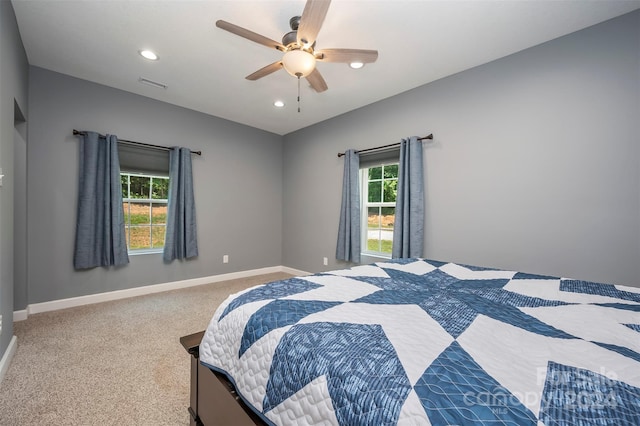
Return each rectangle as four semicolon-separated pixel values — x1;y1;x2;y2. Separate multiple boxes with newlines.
120;173;169;253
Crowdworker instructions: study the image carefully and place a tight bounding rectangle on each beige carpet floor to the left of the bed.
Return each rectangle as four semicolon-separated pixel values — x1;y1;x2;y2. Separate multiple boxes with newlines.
0;273;290;426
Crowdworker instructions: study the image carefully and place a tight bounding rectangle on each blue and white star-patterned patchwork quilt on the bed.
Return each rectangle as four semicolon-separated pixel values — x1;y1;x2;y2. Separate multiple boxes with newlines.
200;259;640;426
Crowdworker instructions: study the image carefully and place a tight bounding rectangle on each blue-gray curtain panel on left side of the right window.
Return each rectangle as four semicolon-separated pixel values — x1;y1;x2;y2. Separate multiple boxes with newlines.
336;149;360;262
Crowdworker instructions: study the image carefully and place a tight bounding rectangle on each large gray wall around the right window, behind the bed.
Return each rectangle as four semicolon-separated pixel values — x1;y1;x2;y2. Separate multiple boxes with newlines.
283;12;640;286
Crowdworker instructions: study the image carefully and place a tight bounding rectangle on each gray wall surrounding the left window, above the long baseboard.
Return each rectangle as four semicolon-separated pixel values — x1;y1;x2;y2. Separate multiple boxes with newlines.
24;67;282;309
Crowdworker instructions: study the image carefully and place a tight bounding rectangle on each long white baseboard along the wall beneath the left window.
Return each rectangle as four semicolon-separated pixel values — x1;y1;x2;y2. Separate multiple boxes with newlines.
13;266;309;322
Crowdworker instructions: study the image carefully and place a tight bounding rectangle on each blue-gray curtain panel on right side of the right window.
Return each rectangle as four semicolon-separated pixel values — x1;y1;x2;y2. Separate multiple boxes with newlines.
391;136;424;259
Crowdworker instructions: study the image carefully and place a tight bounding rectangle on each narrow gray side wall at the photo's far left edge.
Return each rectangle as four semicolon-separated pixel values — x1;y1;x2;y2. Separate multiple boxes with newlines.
0;1;28;358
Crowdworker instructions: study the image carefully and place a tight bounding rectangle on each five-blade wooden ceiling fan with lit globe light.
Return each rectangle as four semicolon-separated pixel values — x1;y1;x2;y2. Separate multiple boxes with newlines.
216;0;378;92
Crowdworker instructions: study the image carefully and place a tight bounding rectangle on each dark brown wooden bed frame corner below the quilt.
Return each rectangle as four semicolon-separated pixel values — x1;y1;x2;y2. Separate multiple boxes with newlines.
180;331;266;426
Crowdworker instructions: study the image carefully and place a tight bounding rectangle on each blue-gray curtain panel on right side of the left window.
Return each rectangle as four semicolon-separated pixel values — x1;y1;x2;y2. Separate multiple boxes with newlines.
163;147;198;262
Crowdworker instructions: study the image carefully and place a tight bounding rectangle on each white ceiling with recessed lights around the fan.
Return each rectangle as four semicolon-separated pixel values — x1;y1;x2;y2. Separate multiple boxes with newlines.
11;0;640;135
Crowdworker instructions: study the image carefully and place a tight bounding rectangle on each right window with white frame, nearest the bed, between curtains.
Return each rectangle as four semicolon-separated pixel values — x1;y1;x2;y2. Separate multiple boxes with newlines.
360;162;398;257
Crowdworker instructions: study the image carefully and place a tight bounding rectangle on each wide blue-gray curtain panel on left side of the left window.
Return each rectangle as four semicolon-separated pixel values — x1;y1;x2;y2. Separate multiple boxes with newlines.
73;132;129;269
